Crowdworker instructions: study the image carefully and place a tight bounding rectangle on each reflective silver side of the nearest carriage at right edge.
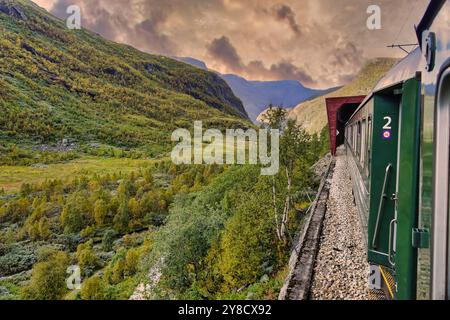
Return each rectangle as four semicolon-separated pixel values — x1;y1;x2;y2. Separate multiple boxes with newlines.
417;1;450;299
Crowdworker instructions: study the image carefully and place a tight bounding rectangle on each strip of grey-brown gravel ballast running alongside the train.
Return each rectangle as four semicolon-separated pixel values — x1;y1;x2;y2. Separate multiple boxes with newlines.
310;148;369;300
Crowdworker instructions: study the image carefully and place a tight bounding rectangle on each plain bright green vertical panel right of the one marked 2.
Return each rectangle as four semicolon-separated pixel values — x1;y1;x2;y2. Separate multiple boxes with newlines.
393;78;422;300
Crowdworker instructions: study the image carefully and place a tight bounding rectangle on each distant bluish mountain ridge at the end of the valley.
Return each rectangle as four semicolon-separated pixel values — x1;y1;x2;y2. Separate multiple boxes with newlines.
176;57;335;122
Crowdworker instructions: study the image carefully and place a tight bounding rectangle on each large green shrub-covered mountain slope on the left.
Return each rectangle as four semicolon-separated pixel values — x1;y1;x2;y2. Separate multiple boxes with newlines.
0;0;250;154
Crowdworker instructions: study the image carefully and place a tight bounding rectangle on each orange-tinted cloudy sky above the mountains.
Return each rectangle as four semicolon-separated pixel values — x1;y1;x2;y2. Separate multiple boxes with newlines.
34;0;428;88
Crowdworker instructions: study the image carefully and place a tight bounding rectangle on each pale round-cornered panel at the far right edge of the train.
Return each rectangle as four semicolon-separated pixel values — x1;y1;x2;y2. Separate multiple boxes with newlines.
431;69;450;300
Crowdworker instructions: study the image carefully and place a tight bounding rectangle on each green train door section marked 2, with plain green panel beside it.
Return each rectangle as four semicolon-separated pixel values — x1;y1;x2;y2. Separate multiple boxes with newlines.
369;78;420;299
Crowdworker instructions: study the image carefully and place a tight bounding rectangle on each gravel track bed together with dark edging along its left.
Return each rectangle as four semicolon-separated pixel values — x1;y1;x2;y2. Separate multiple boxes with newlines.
279;149;368;300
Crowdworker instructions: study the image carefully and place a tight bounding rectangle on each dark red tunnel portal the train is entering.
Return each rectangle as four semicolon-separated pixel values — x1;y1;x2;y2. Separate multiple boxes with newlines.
325;96;366;156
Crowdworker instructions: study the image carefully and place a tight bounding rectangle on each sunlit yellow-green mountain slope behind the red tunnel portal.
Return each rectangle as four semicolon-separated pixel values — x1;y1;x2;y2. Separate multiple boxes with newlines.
289;58;397;133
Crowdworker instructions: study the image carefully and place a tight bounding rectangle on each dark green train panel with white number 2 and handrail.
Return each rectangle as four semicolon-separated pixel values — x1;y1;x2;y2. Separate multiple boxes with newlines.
368;91;400;299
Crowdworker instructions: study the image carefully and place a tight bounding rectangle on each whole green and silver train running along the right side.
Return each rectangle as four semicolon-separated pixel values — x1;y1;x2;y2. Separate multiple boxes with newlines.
345;0;450;299
